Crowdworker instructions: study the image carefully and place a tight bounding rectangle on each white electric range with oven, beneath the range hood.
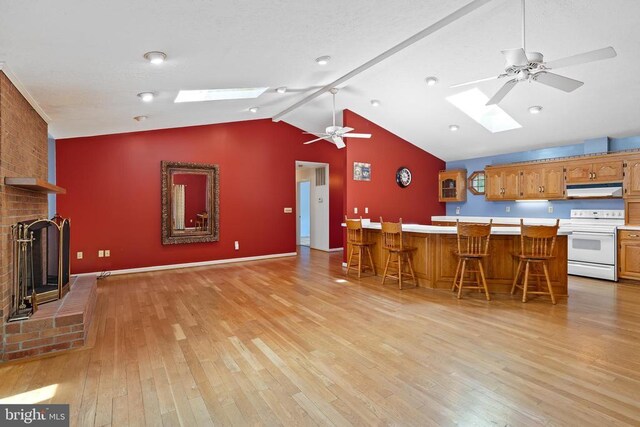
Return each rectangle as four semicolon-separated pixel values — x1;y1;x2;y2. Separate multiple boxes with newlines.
563;209;624;280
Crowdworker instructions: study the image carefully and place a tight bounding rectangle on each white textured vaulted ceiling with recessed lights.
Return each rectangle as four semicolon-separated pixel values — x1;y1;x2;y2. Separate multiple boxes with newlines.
0;0;640;160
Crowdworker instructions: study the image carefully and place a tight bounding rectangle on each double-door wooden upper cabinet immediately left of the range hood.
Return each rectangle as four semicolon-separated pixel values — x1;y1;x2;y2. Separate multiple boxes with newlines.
520;165;565;200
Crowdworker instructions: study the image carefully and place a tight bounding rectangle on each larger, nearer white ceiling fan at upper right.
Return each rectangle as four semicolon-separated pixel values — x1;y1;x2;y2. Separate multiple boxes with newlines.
451;0;616;105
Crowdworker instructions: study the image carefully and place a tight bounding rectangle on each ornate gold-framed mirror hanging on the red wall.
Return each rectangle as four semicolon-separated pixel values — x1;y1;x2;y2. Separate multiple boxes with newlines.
161;160;220;245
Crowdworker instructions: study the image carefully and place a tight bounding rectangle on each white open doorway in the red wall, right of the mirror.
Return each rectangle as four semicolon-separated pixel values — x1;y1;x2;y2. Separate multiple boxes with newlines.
296;161;329;251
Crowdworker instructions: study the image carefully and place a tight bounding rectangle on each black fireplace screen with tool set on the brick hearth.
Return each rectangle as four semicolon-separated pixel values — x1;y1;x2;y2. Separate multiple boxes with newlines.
9;216;70;321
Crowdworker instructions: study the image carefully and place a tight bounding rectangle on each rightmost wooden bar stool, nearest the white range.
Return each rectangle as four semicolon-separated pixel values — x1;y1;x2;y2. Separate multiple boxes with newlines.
511;219;560;304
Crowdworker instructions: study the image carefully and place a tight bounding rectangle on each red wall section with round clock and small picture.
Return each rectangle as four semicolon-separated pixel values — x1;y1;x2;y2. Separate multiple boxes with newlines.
343;110;445;224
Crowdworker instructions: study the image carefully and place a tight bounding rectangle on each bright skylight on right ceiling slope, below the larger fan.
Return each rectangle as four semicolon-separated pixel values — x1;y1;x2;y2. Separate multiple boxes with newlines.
447;88;522;133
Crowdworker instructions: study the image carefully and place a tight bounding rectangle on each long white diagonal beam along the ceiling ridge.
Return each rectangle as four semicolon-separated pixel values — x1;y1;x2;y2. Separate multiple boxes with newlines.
271;0;492;122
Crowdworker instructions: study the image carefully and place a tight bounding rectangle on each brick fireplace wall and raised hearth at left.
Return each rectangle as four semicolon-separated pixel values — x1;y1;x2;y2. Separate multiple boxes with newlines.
0;70;96;361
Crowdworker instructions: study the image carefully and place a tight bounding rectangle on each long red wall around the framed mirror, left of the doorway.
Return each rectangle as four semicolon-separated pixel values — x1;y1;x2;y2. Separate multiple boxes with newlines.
56;119;346;273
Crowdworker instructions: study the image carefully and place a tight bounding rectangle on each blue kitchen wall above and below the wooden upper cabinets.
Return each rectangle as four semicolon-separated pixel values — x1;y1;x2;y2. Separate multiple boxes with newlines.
447;136;640;218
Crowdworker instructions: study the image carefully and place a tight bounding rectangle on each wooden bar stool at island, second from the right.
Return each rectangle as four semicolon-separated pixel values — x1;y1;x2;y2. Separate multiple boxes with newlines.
451;220;493;301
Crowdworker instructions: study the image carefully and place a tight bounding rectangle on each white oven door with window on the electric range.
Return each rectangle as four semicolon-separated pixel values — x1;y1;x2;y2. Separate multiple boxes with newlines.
569;231;616;265
